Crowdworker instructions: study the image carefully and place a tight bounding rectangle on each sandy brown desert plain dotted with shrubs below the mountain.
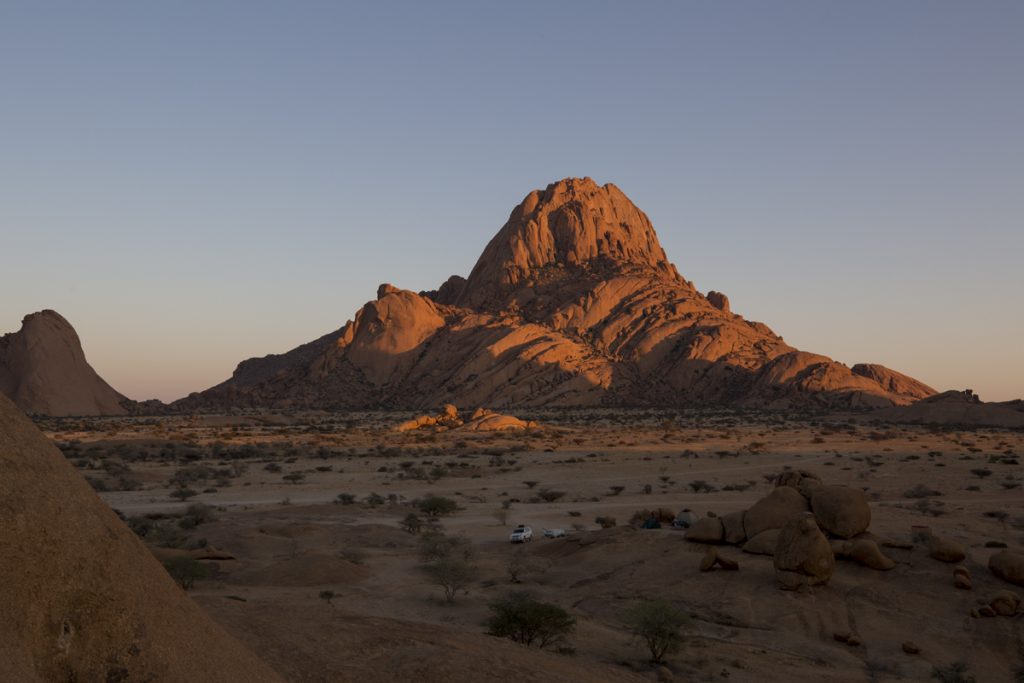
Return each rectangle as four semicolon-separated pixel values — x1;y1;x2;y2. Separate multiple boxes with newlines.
42;411;1024;681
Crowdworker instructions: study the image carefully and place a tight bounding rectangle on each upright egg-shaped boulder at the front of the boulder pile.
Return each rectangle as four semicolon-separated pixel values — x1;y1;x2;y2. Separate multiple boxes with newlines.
774;512;836;590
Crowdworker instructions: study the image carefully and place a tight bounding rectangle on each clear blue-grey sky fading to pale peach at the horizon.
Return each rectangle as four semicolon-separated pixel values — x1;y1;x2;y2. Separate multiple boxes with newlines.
0;0;1024;400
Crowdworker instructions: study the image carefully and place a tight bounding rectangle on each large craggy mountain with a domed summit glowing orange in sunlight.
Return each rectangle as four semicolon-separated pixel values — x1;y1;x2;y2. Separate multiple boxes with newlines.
177;178;934;410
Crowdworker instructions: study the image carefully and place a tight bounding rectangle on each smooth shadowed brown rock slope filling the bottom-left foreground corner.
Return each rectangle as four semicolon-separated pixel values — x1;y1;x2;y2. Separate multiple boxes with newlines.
0;396;282;683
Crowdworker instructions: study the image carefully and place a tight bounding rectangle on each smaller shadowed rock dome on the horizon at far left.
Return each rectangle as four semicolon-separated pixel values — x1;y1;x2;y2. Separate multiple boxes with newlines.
0;310;131;416
